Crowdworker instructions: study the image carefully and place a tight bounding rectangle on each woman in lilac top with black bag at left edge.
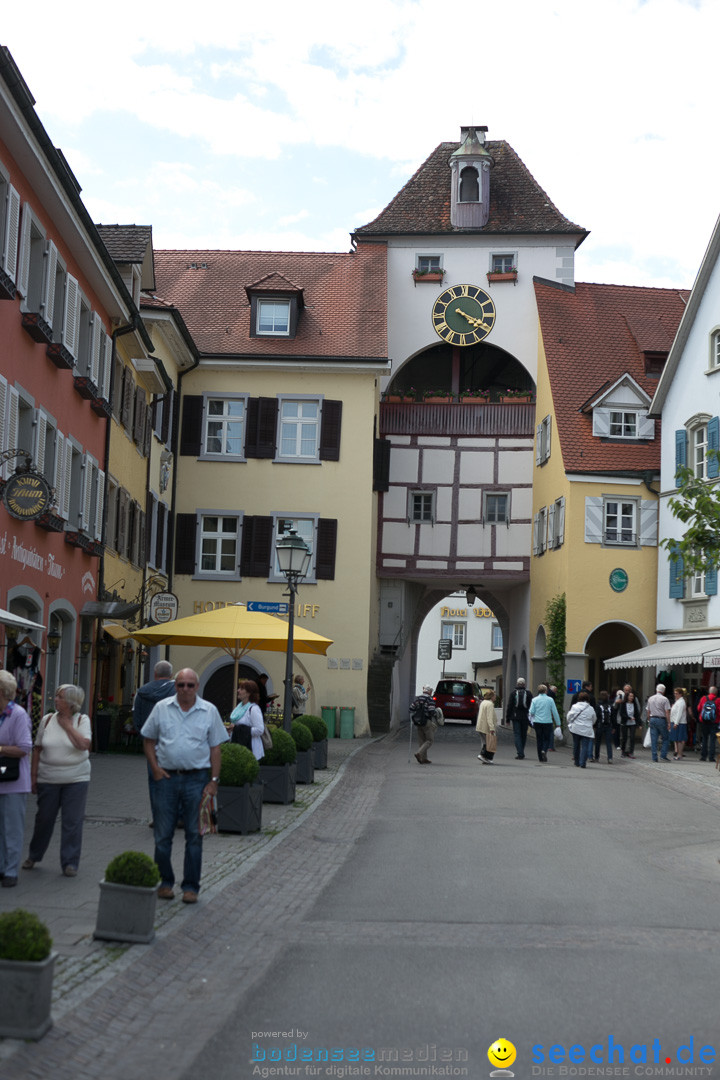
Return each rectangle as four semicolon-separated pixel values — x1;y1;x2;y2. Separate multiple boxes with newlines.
0;671;32;889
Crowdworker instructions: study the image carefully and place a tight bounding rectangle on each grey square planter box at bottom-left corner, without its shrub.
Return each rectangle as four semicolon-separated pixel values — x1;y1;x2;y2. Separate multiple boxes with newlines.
0;953;57;1039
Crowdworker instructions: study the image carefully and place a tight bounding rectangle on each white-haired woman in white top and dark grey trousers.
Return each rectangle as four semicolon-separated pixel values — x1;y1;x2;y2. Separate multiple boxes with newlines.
23;685;92;877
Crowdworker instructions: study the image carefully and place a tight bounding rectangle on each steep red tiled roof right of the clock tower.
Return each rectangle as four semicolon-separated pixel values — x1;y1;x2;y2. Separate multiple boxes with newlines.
535;280;690;472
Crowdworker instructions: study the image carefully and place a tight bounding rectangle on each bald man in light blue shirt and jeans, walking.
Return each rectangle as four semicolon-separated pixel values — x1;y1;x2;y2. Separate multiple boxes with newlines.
140;667;230;904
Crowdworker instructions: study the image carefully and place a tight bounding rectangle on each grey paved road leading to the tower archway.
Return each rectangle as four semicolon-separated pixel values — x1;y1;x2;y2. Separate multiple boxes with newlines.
0;727;720;1080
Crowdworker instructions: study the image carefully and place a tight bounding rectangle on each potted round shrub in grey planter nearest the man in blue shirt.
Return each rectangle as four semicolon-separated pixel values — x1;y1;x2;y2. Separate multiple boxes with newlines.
93;851;160;945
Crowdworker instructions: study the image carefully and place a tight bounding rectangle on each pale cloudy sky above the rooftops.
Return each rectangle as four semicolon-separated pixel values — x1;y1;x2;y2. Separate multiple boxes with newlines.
0;0;720;286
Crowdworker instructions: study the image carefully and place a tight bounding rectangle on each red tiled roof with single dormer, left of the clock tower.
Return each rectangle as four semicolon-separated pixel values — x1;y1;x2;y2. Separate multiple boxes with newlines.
155;243;388;359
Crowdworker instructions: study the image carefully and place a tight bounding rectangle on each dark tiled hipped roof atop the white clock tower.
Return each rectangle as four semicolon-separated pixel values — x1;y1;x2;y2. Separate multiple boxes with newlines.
355;140;587;244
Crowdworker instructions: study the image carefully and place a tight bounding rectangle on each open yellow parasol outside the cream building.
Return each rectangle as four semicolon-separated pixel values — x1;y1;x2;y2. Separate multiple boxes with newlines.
132;604;332;701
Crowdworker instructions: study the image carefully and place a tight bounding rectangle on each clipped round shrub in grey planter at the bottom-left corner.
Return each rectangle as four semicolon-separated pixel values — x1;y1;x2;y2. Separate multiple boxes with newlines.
0;907;56;1039
